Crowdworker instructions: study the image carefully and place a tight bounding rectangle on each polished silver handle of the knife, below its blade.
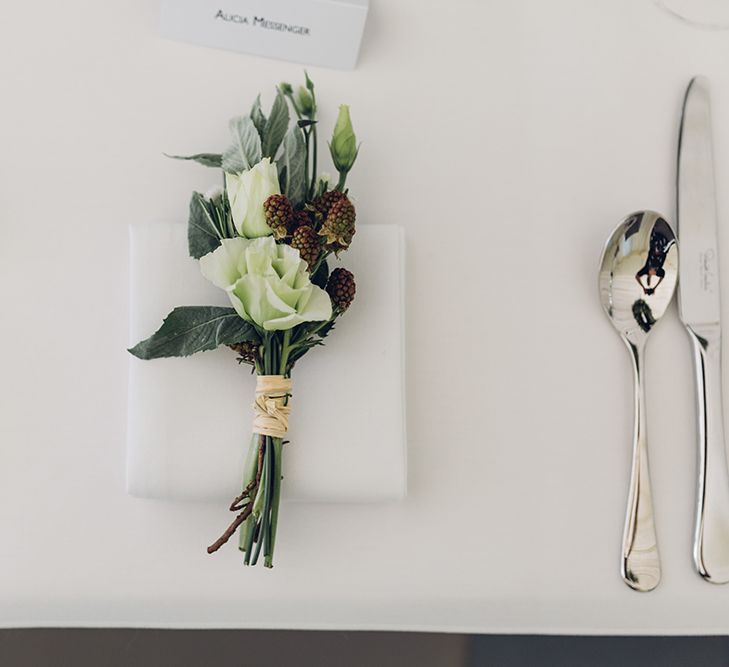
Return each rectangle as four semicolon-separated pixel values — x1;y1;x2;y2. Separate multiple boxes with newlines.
688;324;729;584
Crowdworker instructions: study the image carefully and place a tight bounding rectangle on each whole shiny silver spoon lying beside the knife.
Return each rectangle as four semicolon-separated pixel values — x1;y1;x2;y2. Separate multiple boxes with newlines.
600;211;678;591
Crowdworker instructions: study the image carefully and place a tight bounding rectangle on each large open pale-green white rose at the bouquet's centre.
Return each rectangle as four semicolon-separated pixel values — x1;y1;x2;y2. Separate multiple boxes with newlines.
200;236;332;331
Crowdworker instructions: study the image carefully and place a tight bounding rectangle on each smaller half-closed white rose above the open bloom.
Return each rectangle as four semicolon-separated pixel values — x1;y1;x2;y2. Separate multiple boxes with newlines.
225;158;281;239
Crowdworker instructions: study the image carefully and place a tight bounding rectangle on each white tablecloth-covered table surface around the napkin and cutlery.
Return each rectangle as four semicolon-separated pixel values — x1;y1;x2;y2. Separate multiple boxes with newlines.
0;0;729;634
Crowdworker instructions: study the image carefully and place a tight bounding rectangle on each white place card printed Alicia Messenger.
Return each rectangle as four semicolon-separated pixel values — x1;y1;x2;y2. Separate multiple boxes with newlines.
160;0;369;69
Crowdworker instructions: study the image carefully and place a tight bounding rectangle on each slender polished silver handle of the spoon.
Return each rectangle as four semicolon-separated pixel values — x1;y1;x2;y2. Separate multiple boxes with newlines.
621;342;661;591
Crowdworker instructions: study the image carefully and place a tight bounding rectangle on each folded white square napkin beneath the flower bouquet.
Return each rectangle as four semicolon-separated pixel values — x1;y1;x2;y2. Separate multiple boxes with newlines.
127;223;406;502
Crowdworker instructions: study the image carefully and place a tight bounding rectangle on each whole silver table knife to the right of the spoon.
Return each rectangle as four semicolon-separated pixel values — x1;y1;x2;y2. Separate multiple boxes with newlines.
677;77;729;584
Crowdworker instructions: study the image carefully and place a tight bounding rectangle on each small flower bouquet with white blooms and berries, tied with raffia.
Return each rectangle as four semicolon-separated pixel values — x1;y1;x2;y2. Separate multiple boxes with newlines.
129;75;359;567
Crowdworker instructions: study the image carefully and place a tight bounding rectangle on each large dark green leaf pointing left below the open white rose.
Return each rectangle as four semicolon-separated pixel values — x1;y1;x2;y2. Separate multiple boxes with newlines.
129;306;260;359
